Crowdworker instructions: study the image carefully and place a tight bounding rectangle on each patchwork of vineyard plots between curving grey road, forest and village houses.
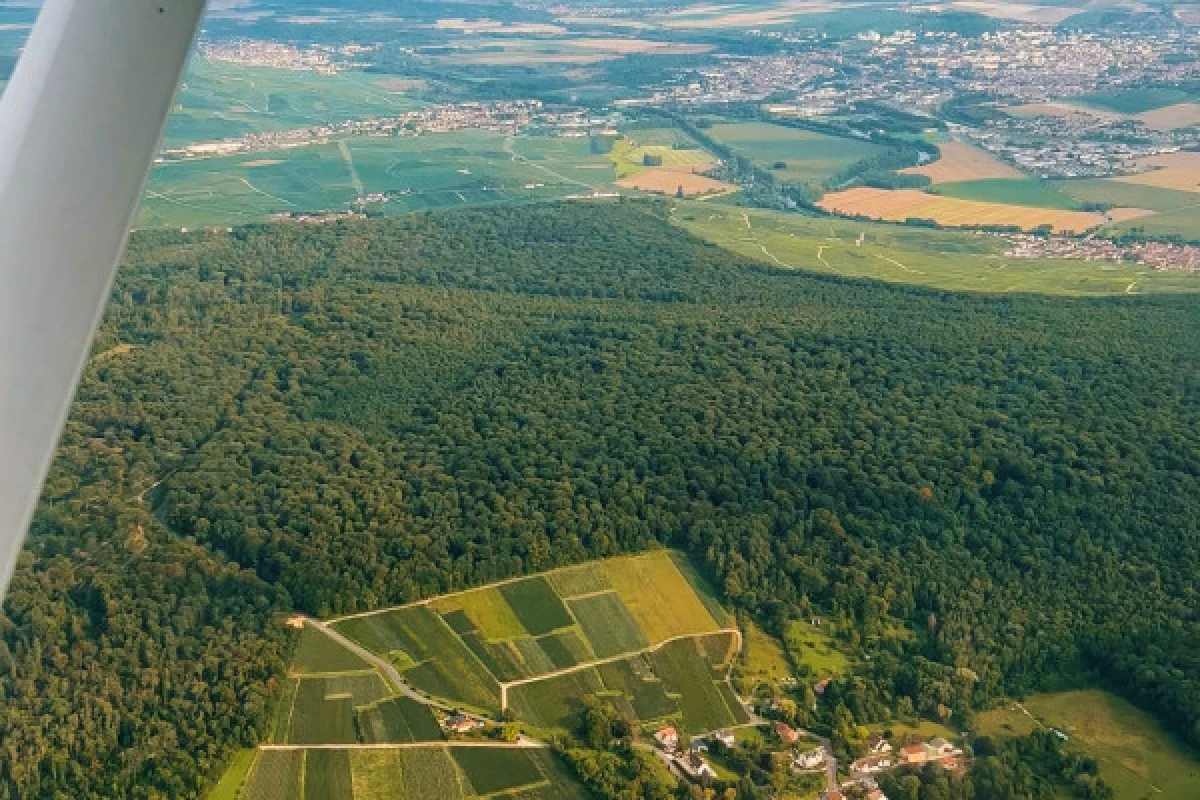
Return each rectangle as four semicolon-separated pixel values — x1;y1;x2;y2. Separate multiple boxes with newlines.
332;552;745;732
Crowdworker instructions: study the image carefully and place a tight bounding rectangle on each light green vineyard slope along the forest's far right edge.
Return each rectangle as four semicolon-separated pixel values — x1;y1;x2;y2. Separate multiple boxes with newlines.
672;203;1200;295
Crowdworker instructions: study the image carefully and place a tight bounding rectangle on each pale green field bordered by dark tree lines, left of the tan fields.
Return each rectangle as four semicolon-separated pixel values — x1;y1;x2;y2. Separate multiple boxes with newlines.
706;122;882;184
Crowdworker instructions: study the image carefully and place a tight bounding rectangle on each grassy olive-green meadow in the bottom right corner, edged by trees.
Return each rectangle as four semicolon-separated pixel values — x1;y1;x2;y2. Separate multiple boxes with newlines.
977;690;1200;800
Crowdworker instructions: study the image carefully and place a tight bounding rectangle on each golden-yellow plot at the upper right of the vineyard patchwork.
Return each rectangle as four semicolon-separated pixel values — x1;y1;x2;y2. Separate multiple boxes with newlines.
601;551;720;644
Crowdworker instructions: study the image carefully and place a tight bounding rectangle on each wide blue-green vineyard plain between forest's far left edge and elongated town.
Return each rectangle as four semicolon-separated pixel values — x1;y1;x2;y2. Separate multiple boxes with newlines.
137;131;613;228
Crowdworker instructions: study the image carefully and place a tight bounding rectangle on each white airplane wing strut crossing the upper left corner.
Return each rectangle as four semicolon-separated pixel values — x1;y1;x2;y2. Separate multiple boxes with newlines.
0;0;204;600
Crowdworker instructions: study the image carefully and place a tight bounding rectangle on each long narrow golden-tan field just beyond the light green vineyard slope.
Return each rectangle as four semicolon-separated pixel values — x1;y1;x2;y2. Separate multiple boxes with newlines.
817;188;1108;233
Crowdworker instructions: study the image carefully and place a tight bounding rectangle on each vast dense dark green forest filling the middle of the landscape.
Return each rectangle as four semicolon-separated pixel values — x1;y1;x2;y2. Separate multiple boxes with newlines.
0;201;1200;798
